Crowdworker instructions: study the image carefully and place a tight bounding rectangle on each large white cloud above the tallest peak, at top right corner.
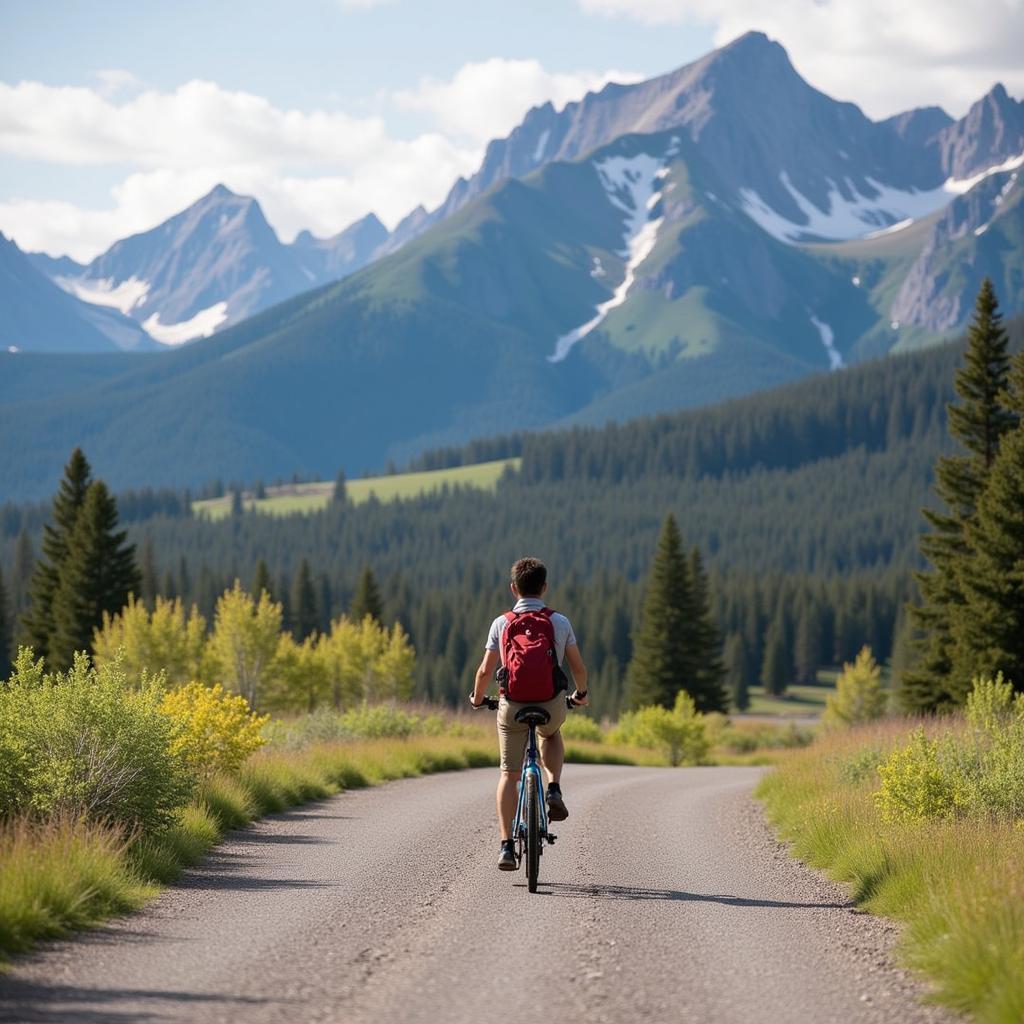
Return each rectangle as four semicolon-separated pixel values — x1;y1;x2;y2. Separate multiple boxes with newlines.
577;0;1024;117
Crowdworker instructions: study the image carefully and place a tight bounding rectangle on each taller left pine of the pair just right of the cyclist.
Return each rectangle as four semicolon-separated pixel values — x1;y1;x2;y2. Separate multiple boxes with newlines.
626;513;695;708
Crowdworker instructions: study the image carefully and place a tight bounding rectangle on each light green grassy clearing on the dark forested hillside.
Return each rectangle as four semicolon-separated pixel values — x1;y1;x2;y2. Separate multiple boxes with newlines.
193;459;520;519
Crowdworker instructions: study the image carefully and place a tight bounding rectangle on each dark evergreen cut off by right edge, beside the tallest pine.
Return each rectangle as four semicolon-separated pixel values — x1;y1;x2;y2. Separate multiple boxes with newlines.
946;424;1024;702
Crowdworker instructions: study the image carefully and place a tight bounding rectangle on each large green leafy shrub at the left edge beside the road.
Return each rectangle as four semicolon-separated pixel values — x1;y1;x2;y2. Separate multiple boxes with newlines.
0;649;191;831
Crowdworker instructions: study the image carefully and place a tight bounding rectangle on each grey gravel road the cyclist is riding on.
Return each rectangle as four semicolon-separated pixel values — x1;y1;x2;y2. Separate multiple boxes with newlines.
0;765;950;1024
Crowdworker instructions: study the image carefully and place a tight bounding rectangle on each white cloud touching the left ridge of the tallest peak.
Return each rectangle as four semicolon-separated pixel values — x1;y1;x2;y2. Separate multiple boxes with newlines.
393;57;643;143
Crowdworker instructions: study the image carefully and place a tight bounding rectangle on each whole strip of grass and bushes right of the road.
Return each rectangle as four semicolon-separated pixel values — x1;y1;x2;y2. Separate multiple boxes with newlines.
760;679;1024;1024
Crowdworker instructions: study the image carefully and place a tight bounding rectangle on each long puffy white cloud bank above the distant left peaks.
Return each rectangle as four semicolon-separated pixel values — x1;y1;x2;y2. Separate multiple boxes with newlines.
0;81;480;259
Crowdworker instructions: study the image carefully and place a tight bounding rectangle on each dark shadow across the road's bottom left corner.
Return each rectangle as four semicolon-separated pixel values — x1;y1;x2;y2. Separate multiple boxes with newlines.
0;978;267;1024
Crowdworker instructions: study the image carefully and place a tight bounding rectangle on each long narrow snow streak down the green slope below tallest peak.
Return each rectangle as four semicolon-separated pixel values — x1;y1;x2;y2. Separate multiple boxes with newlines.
548;153;669;362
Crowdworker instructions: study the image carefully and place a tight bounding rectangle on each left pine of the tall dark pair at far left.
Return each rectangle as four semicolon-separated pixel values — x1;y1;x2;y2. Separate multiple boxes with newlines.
22;449;91;657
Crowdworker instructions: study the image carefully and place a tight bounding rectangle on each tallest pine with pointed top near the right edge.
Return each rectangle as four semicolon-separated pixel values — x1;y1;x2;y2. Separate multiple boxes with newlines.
900;278;1017;712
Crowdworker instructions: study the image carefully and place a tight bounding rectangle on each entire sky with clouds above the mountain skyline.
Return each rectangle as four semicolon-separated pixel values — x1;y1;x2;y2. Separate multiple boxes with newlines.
0;0;1024;259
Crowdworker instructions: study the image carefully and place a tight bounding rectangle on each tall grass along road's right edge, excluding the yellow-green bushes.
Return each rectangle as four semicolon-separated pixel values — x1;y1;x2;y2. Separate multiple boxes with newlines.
759;722;1024;1024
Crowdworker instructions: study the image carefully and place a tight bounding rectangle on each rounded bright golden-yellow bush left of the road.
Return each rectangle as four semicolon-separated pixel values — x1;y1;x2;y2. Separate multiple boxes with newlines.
161;683;269;781
